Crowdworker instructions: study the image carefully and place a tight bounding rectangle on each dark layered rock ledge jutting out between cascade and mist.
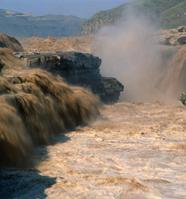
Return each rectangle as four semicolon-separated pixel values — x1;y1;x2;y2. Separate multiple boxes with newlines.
19;52;124;103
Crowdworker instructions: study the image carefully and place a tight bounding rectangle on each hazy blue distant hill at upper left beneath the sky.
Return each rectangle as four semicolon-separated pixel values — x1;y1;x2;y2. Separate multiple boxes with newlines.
0;9;85;37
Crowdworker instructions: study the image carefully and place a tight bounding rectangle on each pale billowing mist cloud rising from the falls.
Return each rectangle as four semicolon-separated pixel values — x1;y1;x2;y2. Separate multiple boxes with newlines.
94;13;169;101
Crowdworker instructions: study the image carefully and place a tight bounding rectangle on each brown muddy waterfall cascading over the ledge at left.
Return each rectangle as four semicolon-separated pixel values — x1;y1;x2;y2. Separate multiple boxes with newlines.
0;69;99;167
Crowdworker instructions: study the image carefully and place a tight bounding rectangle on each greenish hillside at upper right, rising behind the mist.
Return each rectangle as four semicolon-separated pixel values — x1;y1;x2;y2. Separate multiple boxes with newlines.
82;0;186;34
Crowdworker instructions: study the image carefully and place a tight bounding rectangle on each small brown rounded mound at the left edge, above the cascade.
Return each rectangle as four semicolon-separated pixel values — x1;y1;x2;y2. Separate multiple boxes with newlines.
0;33;23;52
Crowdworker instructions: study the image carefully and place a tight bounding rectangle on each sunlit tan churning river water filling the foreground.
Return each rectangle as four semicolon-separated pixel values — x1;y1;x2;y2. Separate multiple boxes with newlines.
0;103;186;199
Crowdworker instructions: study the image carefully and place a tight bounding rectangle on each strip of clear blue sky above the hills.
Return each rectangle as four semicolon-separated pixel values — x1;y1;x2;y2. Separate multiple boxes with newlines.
0;0;127;17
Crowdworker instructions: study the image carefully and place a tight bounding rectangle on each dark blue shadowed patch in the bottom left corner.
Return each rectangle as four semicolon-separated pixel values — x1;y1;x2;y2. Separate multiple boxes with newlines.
0;169;56;199
